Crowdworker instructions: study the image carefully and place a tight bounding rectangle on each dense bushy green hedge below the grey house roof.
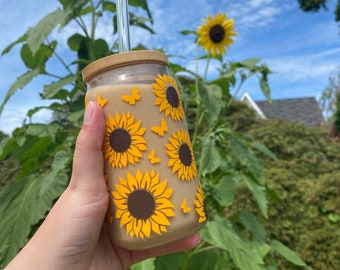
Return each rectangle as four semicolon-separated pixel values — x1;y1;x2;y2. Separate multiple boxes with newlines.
228;116;340;270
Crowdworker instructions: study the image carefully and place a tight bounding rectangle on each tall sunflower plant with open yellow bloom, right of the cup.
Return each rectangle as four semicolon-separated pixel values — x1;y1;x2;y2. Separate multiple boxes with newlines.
157;13;307;270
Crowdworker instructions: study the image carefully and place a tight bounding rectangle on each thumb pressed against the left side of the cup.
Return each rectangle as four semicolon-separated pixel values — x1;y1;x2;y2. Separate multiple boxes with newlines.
70;102;106;194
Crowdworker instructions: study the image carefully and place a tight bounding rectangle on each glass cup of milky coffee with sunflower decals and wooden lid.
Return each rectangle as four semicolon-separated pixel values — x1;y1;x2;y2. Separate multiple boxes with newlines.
83;51;207;250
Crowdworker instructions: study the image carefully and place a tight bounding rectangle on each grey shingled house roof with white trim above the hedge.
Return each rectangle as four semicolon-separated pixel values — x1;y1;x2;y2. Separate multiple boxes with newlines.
241;93;323;126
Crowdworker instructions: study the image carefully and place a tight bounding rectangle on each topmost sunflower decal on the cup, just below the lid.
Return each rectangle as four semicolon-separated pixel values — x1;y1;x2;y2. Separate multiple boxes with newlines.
152;75;184;121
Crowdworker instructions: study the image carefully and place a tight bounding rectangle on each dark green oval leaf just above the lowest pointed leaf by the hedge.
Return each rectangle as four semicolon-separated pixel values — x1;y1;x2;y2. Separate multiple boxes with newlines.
239;211;266;243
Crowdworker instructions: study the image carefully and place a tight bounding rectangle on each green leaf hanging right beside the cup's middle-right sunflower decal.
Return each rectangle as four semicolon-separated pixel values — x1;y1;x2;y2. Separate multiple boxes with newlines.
199;137;223;176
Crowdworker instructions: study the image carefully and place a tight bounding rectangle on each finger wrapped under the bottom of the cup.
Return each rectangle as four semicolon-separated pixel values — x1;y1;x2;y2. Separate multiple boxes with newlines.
131;233;201;263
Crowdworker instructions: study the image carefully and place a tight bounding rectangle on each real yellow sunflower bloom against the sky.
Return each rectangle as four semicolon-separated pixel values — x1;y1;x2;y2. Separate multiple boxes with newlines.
197;13;237;56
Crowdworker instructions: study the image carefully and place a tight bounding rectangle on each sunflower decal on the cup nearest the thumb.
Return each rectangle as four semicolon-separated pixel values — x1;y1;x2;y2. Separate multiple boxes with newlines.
103;112;147;168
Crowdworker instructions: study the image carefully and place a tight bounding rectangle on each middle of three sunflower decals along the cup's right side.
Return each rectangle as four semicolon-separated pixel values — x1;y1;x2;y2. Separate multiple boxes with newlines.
165;130;197;181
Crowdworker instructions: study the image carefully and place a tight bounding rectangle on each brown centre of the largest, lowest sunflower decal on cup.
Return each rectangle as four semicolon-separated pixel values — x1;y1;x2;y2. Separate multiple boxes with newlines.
127;189;156;219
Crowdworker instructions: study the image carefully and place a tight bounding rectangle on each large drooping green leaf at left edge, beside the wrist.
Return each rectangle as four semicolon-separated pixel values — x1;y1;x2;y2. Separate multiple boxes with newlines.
0;152;72;265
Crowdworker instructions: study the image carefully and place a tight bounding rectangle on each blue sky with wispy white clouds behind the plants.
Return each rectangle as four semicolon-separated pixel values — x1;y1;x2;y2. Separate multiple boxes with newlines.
0;0;340;133
